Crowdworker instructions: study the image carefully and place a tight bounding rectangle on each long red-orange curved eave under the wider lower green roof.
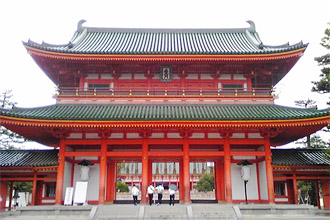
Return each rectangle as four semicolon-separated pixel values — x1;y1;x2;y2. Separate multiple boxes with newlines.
0;113;330;129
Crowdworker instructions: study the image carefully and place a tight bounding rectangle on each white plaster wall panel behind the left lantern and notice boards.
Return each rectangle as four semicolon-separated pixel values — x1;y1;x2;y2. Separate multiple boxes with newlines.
73;164;100;200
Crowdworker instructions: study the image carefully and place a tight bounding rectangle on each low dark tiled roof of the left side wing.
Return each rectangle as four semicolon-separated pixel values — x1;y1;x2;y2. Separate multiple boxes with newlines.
0;150;58;167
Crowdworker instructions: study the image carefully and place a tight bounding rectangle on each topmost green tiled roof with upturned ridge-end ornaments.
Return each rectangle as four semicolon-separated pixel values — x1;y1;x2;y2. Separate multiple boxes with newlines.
25;21;307;55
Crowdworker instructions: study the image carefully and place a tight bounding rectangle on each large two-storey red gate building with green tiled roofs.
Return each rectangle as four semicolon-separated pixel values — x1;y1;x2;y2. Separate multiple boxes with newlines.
0;21;330;207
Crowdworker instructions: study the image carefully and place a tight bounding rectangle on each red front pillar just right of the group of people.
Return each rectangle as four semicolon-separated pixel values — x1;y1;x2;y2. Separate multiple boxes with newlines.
183;136;191;203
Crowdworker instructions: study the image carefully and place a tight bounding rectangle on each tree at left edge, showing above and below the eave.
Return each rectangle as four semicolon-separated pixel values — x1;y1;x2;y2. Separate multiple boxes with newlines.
0;90;26;149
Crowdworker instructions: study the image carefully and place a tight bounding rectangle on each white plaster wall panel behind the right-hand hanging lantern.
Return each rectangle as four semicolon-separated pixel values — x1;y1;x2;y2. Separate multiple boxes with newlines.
231;164;258;200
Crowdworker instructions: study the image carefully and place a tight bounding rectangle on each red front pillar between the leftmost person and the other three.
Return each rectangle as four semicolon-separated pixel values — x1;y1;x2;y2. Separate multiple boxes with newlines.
141;136;149;204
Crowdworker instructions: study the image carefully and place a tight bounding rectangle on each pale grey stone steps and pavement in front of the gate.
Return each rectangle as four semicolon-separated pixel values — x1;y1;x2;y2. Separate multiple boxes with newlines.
0;203;330;220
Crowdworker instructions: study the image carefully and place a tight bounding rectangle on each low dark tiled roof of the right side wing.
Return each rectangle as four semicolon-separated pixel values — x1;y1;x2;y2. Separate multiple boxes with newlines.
272;149;330;168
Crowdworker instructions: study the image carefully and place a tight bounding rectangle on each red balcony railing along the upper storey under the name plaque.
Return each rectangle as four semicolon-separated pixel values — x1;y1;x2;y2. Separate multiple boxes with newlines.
58;88;272;96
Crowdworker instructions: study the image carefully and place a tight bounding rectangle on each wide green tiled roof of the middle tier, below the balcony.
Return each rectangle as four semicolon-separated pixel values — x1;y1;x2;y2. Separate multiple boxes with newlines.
0;104;330;121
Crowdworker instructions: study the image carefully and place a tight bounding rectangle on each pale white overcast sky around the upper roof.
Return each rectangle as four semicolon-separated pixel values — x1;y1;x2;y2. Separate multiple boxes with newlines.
0;0;330;148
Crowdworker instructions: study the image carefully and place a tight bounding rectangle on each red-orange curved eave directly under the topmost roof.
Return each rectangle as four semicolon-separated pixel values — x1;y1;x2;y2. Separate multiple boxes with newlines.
25;45;307;62
